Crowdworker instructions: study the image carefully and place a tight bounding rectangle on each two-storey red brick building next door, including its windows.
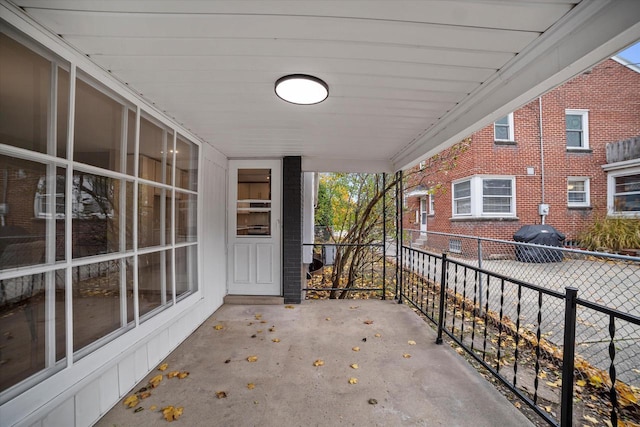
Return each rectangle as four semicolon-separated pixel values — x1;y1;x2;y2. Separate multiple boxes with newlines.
404;58;640;244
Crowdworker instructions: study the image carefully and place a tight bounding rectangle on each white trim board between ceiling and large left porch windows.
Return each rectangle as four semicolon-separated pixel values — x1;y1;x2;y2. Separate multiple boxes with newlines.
0;0;226;157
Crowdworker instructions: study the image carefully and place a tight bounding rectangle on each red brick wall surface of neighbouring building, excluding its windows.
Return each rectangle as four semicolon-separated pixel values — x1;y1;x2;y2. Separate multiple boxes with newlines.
404;59;640;239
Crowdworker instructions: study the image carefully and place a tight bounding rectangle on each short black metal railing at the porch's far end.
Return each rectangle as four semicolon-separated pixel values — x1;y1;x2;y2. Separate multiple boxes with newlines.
303;243;396;299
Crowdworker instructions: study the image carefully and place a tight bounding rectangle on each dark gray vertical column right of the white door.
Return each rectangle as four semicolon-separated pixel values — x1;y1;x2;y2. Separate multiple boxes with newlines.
282;156;306;304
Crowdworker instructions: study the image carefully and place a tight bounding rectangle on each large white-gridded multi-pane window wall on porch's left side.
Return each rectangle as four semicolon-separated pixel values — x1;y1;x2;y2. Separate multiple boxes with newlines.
0;26;200;404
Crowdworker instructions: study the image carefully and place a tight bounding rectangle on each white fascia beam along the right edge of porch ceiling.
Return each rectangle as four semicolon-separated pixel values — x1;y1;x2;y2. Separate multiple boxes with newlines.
391;0;640;174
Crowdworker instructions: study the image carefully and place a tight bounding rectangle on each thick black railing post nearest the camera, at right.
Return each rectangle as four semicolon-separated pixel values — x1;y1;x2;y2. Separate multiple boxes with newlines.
560;286;578;427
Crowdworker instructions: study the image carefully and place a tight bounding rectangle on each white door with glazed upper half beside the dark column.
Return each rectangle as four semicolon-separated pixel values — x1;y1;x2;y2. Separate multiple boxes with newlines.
229;160;282;296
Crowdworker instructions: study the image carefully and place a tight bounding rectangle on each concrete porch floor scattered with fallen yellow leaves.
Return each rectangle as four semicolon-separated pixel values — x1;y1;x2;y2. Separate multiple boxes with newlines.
97;300;532;427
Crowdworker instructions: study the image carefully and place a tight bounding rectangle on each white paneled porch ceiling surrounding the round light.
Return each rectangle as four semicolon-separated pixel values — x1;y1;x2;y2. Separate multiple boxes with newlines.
5;0;640;172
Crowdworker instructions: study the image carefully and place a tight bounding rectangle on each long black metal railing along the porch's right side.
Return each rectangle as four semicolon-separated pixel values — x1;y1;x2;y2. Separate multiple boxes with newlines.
396;246;640;426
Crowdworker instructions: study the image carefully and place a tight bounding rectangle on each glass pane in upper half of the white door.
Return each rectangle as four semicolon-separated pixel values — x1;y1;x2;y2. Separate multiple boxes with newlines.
236;169;271;236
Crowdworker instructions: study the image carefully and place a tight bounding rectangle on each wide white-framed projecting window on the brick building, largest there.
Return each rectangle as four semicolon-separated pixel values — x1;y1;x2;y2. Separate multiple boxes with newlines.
453;176;515;217
